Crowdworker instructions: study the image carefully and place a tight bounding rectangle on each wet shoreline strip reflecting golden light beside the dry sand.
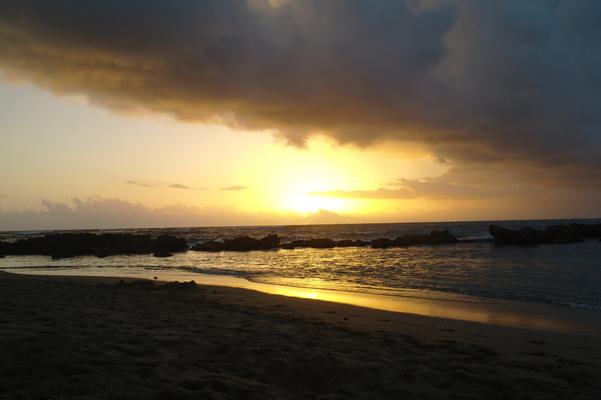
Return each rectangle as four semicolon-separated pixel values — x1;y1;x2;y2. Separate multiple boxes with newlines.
8;268;601;338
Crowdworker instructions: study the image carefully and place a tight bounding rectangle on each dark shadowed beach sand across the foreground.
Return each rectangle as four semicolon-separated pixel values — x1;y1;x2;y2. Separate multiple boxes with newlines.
0;273;601;400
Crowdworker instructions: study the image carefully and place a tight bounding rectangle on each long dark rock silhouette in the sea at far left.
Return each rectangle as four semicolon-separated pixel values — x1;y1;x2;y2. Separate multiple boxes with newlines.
0;233;188;259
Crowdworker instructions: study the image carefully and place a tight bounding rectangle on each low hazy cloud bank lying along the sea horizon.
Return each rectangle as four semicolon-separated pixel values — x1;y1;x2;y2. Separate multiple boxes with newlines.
0;193;601;231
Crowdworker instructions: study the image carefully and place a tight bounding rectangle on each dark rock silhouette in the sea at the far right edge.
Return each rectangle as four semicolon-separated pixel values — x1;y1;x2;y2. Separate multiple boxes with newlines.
488;224;601;246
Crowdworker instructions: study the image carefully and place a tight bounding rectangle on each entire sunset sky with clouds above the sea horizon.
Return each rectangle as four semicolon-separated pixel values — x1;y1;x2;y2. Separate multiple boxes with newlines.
0;0;601;230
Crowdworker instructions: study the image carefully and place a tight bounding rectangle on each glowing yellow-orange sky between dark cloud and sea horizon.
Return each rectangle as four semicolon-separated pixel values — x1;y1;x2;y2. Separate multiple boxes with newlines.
0;82;596;229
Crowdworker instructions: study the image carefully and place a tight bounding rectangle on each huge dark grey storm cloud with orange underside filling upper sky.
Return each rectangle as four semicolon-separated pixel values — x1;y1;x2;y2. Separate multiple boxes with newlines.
0;0;601;186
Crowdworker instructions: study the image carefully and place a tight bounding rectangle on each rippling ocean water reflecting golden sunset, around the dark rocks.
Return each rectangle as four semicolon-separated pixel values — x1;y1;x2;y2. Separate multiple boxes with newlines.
0;219;601;311
